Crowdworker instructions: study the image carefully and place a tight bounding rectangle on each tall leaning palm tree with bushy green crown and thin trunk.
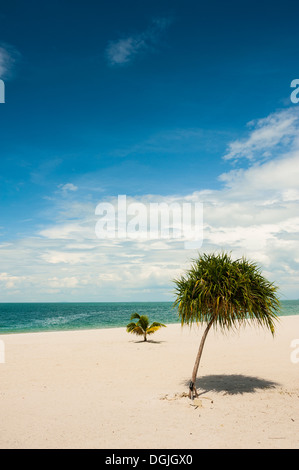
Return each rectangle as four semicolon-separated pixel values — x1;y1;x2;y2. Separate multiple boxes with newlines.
174;253;279;399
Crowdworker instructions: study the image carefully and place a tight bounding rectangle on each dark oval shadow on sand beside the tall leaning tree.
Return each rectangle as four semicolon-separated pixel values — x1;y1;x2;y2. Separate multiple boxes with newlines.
186;374;279;395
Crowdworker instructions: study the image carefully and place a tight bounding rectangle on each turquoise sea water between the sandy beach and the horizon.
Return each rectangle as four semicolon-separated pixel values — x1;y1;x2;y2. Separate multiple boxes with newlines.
0;300;299;334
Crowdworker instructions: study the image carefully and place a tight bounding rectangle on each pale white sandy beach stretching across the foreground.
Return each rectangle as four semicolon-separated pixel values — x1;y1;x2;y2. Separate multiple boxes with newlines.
0;316;299;449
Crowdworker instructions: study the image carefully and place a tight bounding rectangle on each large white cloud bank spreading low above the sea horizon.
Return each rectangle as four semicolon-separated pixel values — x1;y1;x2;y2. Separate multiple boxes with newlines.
0;105;299;301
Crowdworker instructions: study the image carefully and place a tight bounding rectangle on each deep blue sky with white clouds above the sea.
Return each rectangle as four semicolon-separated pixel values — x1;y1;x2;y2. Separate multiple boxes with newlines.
0;0;299;301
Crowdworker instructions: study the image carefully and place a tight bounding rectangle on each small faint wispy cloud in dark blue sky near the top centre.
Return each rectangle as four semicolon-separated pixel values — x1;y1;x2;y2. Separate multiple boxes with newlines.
106;18;171;66
